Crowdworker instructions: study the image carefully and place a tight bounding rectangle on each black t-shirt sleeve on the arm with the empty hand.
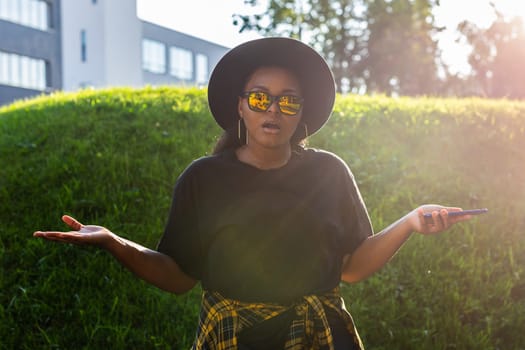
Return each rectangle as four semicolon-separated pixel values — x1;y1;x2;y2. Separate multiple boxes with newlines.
157;165;204;280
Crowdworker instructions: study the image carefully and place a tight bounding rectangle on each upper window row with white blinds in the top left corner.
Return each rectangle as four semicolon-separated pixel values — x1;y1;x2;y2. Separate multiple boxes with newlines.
0;0;49;30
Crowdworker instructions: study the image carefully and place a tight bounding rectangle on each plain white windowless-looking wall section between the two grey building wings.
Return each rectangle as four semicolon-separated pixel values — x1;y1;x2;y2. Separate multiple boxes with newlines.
62;0;142;90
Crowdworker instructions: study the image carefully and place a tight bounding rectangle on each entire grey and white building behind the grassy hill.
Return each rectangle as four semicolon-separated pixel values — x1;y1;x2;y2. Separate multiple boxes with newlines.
0;0;228;105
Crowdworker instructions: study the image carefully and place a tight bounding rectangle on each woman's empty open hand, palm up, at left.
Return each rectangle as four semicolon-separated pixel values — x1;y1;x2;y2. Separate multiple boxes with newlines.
33;215;114;248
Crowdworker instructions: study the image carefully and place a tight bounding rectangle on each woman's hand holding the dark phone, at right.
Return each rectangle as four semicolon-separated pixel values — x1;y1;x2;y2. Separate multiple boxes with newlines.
409;204;472;234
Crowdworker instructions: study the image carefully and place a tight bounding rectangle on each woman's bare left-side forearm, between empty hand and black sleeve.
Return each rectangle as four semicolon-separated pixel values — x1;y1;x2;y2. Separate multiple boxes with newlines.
104;235;197;294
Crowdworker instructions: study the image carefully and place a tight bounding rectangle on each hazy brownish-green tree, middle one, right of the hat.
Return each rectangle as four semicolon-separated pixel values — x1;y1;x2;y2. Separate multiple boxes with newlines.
364;0;441;95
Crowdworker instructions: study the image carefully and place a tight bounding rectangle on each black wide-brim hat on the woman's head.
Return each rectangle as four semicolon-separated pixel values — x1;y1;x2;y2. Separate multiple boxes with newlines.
208;38;335;135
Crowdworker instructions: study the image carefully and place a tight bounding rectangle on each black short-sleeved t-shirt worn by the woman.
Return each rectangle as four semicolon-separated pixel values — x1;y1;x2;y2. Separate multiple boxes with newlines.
158;149;373;302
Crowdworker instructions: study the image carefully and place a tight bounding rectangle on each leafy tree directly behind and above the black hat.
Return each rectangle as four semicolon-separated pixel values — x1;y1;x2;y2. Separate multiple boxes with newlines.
234;0;367;91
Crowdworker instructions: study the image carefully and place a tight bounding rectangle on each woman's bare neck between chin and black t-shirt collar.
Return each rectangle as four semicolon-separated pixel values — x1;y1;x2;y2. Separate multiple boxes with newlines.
235;145;292;170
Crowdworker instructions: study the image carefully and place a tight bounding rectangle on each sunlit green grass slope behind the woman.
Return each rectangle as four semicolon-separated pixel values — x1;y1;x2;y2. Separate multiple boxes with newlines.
0;88;525;349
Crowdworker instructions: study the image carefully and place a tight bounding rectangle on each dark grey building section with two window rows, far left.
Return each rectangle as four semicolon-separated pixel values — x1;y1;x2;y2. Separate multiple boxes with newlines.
0;0;62;105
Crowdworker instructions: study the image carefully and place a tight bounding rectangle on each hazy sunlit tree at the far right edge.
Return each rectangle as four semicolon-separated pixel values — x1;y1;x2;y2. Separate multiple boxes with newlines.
458;10;525;99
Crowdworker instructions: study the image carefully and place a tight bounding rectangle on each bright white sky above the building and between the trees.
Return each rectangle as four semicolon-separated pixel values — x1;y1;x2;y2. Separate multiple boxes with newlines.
137;0;525;73
